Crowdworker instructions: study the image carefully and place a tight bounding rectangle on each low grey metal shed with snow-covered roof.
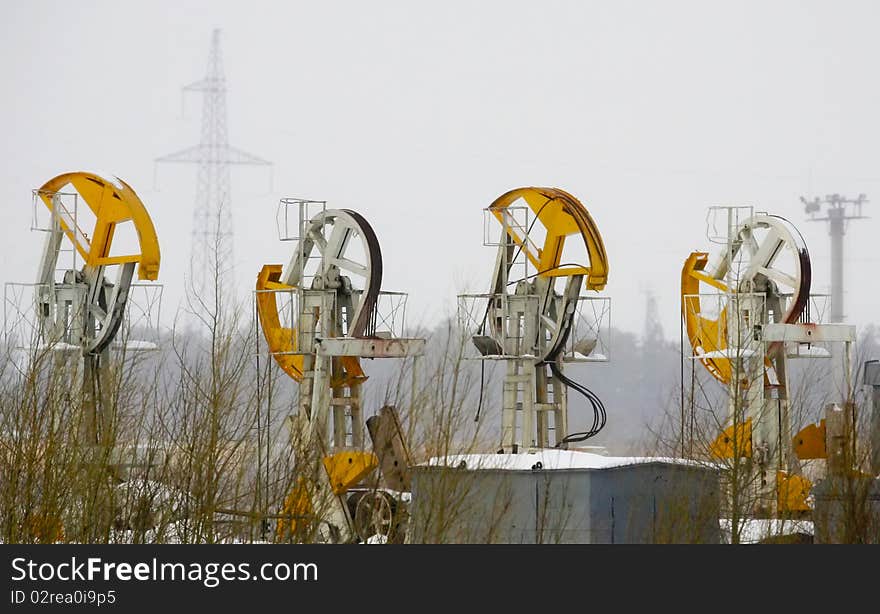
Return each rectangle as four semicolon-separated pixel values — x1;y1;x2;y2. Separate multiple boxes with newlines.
409;450;721;544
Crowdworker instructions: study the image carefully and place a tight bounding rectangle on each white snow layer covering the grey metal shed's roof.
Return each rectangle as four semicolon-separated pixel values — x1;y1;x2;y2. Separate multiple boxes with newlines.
419;449;714;471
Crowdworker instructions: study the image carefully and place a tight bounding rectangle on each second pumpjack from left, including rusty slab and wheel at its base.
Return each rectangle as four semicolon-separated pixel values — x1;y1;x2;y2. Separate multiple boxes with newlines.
255;198;425;542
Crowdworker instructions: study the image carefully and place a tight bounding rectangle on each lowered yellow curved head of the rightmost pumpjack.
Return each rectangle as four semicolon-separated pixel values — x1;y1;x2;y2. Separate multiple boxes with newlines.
681;252;731;384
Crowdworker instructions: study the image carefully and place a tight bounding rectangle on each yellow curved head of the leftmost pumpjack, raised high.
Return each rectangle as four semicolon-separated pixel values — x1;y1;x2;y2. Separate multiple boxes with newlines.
38;171;160;281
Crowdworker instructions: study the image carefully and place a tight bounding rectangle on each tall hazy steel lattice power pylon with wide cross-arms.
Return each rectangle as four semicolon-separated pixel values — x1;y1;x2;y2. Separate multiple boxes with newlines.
156;29;272;312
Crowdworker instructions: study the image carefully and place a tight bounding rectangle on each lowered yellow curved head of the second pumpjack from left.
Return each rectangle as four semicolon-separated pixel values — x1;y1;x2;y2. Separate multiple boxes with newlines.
256;264;367;388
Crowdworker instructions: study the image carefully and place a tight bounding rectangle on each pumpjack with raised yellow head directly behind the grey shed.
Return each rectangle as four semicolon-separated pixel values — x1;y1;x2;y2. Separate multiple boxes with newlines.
459;187;608;453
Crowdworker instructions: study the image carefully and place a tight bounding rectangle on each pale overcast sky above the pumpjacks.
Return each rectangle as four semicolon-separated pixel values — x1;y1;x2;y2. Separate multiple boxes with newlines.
0;0;880;338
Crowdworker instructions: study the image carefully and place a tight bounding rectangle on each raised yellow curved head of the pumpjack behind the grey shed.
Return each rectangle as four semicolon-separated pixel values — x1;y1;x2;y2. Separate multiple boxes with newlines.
489;187;608;291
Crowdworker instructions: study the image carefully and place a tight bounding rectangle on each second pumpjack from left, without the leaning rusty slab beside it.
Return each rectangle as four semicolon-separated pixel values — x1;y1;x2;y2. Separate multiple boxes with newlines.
255;198;425;542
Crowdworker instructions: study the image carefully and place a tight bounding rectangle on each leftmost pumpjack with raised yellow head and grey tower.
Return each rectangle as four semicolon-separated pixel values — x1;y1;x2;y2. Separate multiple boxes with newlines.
28;172;160;472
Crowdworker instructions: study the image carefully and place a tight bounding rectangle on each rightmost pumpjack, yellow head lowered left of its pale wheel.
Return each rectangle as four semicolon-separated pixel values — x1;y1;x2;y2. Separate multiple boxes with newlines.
682;207;856;517
